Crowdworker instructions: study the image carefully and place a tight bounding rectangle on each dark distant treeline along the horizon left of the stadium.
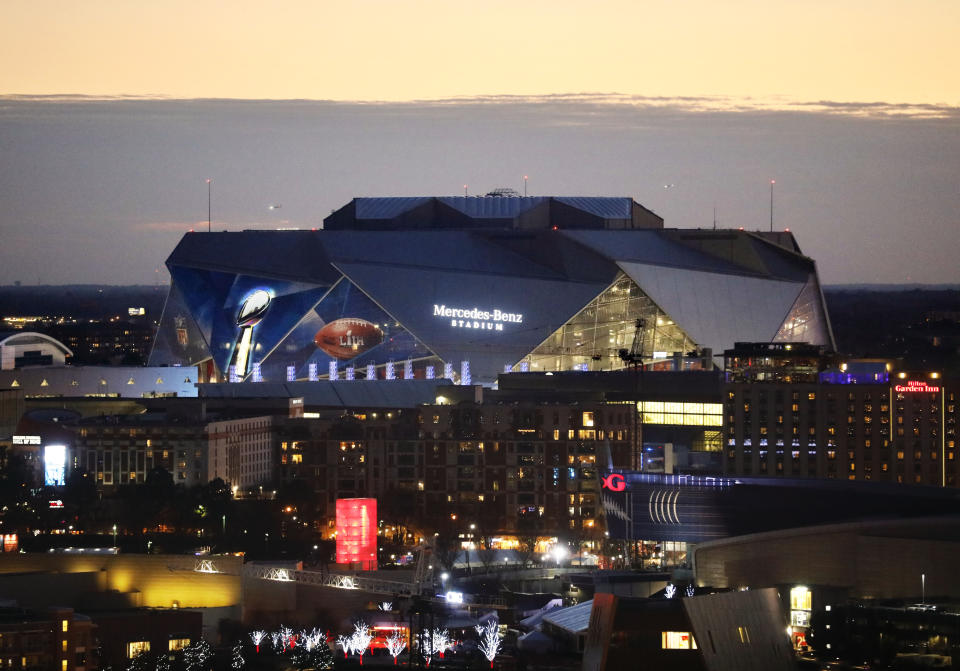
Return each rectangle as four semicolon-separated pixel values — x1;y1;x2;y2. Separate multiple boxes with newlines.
0;284;167;320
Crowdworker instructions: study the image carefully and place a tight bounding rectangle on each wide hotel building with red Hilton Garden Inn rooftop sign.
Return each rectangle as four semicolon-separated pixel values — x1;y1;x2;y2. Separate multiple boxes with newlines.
724;343;960;487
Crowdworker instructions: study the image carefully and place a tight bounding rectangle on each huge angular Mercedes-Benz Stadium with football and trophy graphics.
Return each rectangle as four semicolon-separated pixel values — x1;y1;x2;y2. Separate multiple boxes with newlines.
150;196;833;384
